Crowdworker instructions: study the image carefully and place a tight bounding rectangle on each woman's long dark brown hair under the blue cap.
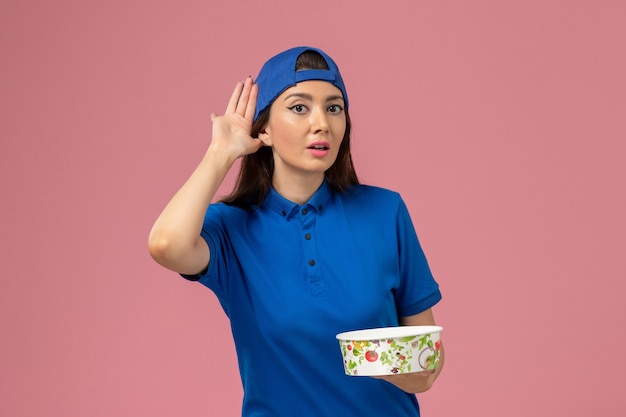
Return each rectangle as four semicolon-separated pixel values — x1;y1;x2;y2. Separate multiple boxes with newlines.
222;51;359;209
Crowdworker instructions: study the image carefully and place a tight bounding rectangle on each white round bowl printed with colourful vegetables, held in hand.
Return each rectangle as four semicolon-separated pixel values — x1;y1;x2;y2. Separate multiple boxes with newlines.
336;326;443;376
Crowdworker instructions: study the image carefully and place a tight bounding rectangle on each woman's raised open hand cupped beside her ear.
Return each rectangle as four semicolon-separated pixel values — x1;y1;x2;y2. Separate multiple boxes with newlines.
210;77;263;160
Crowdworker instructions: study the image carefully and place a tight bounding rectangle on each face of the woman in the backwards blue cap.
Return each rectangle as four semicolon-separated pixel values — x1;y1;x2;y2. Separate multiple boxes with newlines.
259;81;346;183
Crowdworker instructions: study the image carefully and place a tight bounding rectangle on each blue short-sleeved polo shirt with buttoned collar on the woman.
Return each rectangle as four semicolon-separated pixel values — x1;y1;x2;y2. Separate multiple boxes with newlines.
185;182;441;417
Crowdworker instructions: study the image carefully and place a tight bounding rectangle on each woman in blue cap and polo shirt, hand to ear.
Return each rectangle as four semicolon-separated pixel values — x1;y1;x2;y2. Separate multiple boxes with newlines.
149;47;443;417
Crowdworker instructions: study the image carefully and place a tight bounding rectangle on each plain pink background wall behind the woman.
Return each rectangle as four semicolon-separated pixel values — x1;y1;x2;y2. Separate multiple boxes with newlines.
0;0;626;417
